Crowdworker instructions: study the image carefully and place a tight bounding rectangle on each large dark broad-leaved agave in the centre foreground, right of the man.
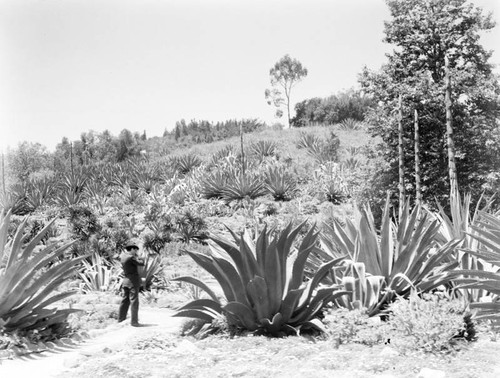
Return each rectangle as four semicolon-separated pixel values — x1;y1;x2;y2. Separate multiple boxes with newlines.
175;223;347;336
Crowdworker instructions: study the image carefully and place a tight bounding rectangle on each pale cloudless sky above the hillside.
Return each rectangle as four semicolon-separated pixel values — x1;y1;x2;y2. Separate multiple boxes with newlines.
0;0;500;150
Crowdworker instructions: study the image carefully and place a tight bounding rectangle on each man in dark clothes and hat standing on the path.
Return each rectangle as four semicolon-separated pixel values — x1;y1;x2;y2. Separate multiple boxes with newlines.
118;240;144;327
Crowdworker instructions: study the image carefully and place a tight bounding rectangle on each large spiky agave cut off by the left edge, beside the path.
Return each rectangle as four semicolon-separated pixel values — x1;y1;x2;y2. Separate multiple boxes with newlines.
0;212;85;331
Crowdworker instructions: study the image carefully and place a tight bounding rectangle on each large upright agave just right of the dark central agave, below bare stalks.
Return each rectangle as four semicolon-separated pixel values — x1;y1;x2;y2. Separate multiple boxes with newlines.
321;198;459;309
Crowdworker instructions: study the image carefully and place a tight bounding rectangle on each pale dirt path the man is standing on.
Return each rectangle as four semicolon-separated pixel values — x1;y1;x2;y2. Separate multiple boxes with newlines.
0;308;184;378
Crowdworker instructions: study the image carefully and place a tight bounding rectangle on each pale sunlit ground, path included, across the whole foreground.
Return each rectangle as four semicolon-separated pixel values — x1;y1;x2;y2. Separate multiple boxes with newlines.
0;307;500;378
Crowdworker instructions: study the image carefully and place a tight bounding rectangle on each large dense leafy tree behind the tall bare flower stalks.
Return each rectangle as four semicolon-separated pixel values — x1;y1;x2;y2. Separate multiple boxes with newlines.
359;0;500;210
